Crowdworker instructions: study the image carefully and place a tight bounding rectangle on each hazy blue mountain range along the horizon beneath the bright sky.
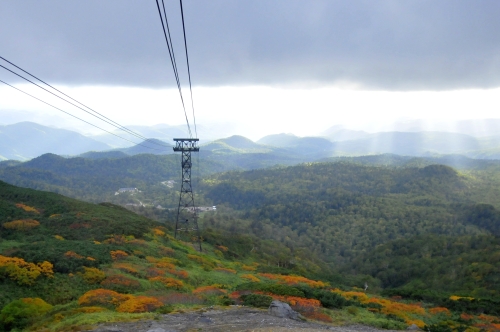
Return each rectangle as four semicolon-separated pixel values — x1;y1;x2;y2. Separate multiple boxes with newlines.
4;122;500;161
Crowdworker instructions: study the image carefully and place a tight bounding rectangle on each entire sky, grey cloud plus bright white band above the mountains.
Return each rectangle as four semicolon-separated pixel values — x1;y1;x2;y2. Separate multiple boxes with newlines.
0;0;500;140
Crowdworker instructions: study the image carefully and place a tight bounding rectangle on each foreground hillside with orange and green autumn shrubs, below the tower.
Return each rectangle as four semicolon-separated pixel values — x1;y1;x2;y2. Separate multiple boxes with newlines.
0;182;500;331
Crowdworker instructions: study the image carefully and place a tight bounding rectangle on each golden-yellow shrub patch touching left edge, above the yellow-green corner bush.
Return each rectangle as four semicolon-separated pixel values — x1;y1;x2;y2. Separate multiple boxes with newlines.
0;255;54;285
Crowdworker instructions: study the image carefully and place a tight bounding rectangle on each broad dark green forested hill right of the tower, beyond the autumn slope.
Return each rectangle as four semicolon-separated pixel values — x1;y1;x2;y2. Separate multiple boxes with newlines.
202;162;500;294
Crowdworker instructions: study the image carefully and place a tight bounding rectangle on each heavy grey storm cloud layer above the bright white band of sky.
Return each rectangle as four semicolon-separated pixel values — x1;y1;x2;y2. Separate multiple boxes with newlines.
0;0;500;90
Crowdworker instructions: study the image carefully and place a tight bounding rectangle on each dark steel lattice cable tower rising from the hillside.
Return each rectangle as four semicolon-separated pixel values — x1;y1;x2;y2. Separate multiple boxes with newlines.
174;138;201;251
